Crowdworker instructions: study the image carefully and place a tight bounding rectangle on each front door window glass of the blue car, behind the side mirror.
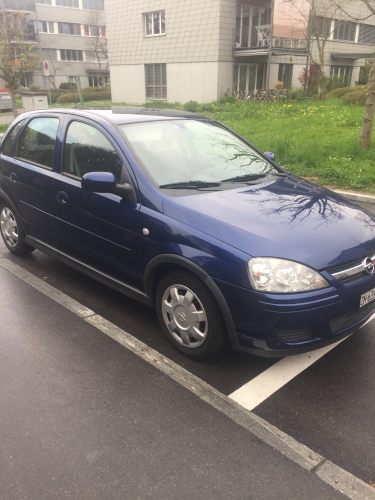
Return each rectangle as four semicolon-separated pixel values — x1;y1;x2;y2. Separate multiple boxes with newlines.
63;122;122;182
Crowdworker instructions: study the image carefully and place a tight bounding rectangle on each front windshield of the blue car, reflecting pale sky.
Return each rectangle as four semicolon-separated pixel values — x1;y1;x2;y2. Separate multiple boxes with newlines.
121;120;278;187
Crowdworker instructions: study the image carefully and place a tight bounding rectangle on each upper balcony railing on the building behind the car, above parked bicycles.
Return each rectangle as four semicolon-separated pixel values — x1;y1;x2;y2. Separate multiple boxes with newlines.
234;25;306;50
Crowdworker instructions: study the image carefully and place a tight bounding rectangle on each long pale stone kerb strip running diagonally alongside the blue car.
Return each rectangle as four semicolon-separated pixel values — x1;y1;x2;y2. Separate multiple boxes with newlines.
0;256;375;500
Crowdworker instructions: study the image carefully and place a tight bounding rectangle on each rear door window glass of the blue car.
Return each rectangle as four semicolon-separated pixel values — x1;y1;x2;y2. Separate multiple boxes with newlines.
18;117;59;170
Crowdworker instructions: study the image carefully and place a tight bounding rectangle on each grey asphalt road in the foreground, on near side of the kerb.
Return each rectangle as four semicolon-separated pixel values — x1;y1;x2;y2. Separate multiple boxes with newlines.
0;267;352;500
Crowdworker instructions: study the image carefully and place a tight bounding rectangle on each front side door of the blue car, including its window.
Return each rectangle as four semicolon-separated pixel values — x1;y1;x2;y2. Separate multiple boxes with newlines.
53;118;139;288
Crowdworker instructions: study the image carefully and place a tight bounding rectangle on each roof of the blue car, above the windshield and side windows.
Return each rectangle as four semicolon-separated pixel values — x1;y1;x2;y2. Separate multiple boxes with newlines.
22;106;211;125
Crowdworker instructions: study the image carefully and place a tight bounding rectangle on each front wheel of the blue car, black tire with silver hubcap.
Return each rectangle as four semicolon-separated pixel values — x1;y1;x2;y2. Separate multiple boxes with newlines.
156;271;228;359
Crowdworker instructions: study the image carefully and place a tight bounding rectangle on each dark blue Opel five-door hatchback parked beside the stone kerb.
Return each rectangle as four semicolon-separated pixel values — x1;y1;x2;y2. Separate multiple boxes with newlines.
0;108;375;359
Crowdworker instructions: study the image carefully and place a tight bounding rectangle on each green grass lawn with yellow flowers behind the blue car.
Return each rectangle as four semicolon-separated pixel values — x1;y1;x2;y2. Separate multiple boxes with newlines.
12;99;375;194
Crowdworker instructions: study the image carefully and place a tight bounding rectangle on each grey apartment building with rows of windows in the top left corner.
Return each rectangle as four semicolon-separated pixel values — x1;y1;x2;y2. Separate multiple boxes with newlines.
0;0;109;88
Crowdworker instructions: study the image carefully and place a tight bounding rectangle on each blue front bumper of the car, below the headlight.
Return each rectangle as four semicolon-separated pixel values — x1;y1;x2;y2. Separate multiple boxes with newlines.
215;275;375;357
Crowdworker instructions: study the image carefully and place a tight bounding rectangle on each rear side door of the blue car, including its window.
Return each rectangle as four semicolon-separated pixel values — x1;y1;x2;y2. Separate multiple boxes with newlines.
1;116;59;236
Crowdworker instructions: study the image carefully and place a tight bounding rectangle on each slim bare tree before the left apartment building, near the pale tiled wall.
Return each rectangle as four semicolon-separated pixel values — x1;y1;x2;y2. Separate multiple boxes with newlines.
84;10;109;88
